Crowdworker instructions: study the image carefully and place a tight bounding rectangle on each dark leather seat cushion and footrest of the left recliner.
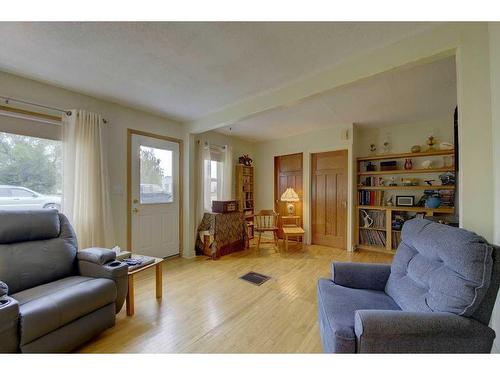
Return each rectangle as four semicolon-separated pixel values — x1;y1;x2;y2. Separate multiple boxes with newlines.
12;276;116;345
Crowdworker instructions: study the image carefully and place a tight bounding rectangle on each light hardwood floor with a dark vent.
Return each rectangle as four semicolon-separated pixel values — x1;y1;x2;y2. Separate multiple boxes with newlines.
80;241;392;353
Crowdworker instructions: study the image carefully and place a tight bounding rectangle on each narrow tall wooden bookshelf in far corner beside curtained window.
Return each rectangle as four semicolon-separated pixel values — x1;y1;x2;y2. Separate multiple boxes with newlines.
236;164;255;239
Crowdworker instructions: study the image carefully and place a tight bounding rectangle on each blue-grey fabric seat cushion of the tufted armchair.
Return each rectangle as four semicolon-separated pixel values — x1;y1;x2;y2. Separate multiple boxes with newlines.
318;279;400;353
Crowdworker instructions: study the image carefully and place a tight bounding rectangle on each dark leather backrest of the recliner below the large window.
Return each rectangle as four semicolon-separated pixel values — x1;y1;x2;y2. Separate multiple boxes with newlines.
0;210;77;293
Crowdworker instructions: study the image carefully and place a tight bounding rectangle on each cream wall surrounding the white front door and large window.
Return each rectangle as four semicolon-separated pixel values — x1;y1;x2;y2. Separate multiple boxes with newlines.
0;72;194;256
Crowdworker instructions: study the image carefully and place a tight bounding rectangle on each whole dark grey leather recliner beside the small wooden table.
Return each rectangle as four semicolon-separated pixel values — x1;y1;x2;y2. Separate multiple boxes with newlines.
0;210;128;353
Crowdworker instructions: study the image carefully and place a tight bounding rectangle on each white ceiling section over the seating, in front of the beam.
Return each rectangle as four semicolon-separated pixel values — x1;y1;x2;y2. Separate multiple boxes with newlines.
0;22;436;121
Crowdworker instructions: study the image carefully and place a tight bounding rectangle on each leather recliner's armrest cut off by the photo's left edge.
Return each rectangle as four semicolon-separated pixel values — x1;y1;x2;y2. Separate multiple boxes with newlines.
0;281;19;353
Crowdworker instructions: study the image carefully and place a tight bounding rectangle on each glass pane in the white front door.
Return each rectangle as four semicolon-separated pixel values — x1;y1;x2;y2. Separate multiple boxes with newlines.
139;145;174;204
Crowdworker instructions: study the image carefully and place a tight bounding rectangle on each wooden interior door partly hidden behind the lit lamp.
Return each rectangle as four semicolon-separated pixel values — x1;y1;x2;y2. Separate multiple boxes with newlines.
274;153;304;238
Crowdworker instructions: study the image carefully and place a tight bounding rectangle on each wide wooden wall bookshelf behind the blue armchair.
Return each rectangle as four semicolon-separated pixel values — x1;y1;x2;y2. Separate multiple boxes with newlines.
354;150;456;254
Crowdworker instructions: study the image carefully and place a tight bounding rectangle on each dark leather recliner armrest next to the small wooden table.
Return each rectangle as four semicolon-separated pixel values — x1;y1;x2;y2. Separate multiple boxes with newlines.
78;247;128;313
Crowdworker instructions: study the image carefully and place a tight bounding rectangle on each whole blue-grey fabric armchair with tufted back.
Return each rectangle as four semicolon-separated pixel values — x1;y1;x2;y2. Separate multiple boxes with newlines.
318;219;500;353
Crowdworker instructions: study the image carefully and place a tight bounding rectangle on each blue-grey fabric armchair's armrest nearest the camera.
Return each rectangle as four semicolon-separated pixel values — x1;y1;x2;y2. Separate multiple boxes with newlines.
354;310;495;353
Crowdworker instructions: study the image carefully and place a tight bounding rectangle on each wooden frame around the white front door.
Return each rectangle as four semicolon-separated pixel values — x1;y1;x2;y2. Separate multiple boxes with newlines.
127;128;184;256
